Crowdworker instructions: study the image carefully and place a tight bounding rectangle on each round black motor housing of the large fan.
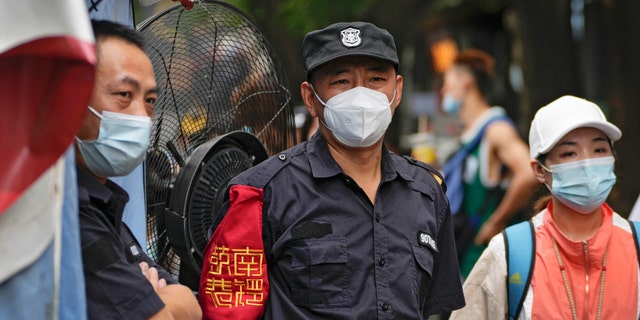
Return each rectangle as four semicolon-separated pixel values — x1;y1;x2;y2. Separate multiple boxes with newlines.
165;131;268;284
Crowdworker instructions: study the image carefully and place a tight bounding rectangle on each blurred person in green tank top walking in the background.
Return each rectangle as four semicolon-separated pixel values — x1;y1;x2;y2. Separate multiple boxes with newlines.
441;49;537;278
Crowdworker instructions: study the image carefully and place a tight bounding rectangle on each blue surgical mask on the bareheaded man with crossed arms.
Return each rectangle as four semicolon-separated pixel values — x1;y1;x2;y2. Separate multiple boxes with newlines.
76;107;151;178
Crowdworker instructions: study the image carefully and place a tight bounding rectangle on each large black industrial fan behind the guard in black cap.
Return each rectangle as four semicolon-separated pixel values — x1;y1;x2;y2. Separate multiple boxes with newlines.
138;1;295;290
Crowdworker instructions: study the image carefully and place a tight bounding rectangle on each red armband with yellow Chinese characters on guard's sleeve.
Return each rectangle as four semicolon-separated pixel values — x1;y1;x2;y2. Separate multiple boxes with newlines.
198;185;269;320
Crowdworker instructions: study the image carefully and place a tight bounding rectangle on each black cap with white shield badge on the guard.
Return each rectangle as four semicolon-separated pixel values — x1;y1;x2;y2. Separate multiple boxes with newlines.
302;22;398;76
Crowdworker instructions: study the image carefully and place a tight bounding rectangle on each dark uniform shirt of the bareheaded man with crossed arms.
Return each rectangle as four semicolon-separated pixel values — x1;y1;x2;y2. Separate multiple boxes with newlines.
78;168;176;319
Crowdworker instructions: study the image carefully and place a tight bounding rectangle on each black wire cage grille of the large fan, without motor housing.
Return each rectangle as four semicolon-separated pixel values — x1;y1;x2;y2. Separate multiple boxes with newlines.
139;1;295;277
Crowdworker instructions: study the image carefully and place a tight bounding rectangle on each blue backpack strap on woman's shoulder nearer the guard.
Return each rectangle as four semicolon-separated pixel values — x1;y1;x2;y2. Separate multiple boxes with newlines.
502;220;536;319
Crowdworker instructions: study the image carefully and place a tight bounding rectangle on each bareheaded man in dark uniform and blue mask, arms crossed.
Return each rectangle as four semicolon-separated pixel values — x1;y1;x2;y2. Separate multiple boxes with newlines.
75;21;201;319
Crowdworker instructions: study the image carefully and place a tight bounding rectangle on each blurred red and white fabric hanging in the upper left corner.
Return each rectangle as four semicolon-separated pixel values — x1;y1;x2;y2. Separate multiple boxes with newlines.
0;0;96;215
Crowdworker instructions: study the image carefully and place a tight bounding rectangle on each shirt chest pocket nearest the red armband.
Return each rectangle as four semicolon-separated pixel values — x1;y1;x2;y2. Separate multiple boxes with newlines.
286;237;351;307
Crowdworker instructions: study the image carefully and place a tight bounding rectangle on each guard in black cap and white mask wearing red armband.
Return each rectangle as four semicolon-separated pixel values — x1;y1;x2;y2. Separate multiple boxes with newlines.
198;22;464;319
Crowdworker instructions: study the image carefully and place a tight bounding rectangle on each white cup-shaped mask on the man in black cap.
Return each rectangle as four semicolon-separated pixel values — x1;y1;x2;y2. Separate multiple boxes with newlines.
313;87;396;147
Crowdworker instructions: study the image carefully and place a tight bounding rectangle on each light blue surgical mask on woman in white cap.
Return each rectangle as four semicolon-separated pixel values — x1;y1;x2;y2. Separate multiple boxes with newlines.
542;157;616;214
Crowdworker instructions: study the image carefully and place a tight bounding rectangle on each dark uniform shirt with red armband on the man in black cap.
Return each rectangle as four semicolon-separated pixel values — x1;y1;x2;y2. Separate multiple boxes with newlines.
199;133;464;319
